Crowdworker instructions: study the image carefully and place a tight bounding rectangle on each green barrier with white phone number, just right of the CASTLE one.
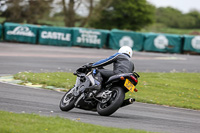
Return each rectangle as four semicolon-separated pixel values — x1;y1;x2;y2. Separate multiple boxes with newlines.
73;28;109;48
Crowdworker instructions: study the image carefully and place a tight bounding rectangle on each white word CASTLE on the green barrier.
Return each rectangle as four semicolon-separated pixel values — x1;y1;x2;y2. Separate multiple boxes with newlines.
41;31;71;41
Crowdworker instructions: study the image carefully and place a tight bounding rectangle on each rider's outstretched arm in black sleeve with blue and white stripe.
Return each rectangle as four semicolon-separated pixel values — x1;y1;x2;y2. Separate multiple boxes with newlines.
92;53;120;67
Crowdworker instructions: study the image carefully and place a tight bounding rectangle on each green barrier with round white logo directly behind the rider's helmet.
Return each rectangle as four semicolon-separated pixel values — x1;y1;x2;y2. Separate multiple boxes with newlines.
109;30;144;51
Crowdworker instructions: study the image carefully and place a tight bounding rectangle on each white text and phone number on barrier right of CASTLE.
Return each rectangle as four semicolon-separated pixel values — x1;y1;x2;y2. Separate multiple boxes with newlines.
76;29;101;44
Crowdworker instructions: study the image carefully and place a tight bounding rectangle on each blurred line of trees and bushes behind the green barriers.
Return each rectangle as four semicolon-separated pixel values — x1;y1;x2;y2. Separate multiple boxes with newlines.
0;0;200;30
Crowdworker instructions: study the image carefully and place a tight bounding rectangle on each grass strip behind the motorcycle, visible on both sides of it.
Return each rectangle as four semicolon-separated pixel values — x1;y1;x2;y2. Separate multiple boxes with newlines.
14;72;200;110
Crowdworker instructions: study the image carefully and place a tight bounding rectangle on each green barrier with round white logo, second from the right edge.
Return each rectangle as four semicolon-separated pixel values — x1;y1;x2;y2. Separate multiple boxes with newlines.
144;33;182;53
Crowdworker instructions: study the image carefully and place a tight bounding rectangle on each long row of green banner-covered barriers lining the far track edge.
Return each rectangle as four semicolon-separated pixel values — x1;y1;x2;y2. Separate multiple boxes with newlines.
0;23;200;53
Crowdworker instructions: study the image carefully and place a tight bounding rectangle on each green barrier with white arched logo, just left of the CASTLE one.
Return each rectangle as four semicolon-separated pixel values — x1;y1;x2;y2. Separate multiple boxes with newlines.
4;23;39;44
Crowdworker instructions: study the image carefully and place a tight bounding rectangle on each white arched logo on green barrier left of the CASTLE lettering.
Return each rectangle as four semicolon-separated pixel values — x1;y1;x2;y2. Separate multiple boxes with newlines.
7;26;35;37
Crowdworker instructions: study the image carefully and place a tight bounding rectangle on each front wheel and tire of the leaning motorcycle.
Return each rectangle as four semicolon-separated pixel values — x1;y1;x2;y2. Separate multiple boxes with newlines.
60;88;77;111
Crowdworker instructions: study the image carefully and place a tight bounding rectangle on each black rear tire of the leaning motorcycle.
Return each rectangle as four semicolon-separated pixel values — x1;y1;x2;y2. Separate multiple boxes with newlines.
97;87;125;116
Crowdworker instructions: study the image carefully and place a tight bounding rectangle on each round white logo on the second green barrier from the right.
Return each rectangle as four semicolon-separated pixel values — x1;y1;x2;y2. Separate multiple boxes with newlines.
154;35;169;49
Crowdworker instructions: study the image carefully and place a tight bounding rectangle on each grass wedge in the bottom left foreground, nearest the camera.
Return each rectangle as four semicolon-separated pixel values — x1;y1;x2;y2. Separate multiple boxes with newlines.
0;111;152;133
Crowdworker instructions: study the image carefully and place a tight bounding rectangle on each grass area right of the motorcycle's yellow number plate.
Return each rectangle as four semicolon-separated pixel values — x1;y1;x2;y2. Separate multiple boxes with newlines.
128;73;200;110
